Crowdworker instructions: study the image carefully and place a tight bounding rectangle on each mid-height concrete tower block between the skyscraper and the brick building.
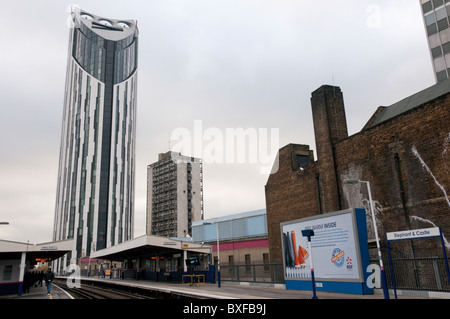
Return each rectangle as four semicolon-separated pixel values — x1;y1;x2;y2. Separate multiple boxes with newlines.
146;152;203;237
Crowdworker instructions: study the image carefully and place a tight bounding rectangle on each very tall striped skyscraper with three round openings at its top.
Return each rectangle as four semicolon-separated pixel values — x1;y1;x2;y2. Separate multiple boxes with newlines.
53;9;138;268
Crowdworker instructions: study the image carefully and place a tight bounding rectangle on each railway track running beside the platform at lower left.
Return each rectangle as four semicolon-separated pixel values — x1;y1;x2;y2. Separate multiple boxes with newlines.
55;280;153;299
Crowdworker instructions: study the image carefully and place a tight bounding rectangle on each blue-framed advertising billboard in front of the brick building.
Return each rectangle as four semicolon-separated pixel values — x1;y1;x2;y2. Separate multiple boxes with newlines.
281;209;373;294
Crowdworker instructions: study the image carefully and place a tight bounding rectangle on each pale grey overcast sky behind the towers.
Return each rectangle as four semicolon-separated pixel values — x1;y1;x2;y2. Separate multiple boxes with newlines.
0;0;434;243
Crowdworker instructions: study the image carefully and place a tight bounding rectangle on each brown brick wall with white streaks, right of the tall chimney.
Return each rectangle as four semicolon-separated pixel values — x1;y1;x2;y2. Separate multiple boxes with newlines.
336;94;450;255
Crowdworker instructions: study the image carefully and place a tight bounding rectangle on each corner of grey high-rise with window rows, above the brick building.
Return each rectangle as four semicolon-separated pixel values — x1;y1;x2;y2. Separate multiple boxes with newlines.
419;0;450;82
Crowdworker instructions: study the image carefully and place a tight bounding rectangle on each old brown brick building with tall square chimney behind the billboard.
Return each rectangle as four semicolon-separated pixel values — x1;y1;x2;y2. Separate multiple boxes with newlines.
265;80;450;260
